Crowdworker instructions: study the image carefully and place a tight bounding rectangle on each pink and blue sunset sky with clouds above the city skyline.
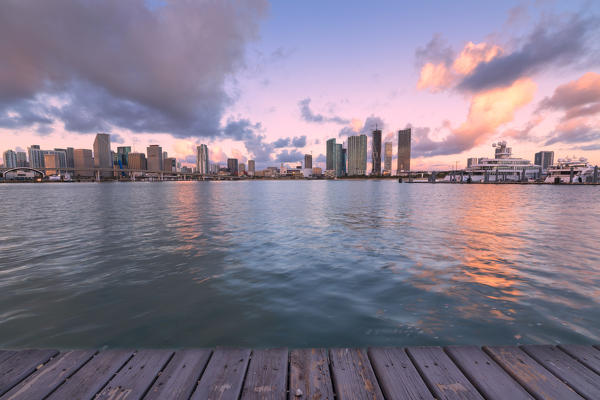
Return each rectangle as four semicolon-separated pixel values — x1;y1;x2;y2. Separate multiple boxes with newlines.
0;0;600;169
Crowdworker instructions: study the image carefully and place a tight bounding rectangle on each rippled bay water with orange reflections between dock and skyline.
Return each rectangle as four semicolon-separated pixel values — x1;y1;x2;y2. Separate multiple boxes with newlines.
0;180;600;348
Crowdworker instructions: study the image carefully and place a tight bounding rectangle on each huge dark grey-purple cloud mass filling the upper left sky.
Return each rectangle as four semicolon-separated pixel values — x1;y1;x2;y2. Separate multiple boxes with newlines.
0;0;267;137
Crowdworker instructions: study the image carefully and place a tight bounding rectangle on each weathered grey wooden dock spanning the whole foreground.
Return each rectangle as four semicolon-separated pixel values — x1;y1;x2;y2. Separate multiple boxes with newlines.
0;345;600;400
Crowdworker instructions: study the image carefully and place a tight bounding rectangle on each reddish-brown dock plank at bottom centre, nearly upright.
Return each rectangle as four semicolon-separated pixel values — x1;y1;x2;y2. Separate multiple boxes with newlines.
289;349;333;400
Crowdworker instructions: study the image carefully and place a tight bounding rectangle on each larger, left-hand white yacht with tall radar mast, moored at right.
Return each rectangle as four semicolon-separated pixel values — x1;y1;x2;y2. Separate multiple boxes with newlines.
463;141;541;182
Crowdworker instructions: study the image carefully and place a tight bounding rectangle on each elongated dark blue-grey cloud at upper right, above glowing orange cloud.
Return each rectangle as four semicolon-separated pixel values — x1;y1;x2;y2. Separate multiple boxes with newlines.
457;15;600;92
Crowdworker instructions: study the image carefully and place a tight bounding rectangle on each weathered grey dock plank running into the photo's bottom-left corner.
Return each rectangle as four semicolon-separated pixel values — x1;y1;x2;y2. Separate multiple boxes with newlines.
2;350;95;400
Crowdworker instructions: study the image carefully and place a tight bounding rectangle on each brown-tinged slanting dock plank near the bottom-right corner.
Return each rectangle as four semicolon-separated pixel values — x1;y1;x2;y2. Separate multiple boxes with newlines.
483;346;581;400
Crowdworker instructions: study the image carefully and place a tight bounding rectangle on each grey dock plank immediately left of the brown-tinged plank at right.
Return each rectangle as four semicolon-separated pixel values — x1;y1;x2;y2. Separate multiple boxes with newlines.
446;346;533;400
